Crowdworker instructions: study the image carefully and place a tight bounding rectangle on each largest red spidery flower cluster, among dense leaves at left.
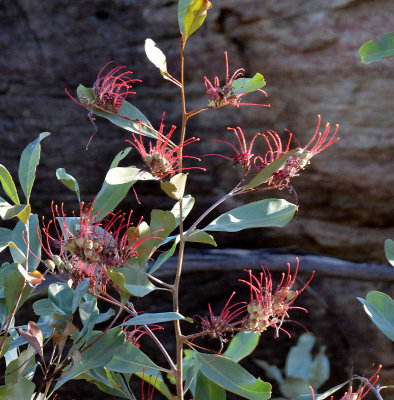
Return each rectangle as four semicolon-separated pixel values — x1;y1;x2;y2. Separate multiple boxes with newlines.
43;203;162;290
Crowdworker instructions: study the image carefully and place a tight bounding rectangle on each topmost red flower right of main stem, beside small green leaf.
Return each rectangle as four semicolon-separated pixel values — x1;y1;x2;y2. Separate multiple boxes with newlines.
204;51;270;108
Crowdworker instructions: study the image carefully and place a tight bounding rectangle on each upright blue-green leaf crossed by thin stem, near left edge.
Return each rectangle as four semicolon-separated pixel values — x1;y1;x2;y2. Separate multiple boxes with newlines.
10;214;41;272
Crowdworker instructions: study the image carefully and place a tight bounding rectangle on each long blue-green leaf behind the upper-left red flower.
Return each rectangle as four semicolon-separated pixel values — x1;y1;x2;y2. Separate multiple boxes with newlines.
77;85;158;139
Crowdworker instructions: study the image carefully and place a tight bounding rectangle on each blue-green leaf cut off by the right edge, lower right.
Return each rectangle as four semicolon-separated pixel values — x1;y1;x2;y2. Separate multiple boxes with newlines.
357;290;394;341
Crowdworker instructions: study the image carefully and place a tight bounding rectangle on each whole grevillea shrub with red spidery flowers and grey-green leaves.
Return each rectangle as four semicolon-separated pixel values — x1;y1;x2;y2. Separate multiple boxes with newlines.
0;0;388;400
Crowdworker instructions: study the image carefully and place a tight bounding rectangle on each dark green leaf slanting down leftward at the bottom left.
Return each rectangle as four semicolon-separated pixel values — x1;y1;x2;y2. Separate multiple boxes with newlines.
54;328;125;390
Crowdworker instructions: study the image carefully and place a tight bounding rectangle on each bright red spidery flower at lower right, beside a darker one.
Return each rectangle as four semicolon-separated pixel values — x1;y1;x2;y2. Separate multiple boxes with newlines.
240;258;314;336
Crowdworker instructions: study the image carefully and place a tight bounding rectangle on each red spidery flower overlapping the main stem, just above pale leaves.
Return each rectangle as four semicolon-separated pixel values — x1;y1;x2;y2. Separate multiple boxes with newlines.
127;116;205;181
